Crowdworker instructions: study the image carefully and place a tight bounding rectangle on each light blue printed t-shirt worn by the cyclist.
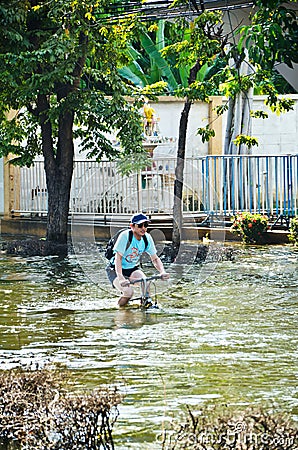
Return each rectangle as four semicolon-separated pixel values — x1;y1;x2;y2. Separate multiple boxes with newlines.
111;229;156;269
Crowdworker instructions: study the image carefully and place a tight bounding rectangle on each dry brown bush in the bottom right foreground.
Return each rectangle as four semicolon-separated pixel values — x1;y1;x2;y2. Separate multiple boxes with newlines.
162;408;298;450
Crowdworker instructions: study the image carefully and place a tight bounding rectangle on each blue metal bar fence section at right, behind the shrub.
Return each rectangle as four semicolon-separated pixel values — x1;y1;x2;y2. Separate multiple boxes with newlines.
202;155;298;216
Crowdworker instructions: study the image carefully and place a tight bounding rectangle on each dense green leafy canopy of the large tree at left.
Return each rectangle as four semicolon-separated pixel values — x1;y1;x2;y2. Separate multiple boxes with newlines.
0;0;149;171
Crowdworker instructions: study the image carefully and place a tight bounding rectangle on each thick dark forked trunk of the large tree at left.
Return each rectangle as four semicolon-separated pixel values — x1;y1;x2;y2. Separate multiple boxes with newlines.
36;32;88;254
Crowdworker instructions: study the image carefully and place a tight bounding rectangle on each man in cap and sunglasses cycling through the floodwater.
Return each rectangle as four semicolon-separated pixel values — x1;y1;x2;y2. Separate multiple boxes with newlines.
106;214;170;306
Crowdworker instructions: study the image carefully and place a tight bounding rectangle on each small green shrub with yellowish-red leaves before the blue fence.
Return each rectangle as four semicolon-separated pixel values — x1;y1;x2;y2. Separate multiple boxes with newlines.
231;212;268;244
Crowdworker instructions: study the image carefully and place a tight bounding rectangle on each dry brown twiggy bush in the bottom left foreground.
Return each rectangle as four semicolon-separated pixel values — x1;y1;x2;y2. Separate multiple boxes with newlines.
0;368;121;450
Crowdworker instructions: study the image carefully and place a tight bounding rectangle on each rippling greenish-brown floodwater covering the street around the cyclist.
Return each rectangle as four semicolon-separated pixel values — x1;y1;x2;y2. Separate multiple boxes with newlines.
0;244;298;450
